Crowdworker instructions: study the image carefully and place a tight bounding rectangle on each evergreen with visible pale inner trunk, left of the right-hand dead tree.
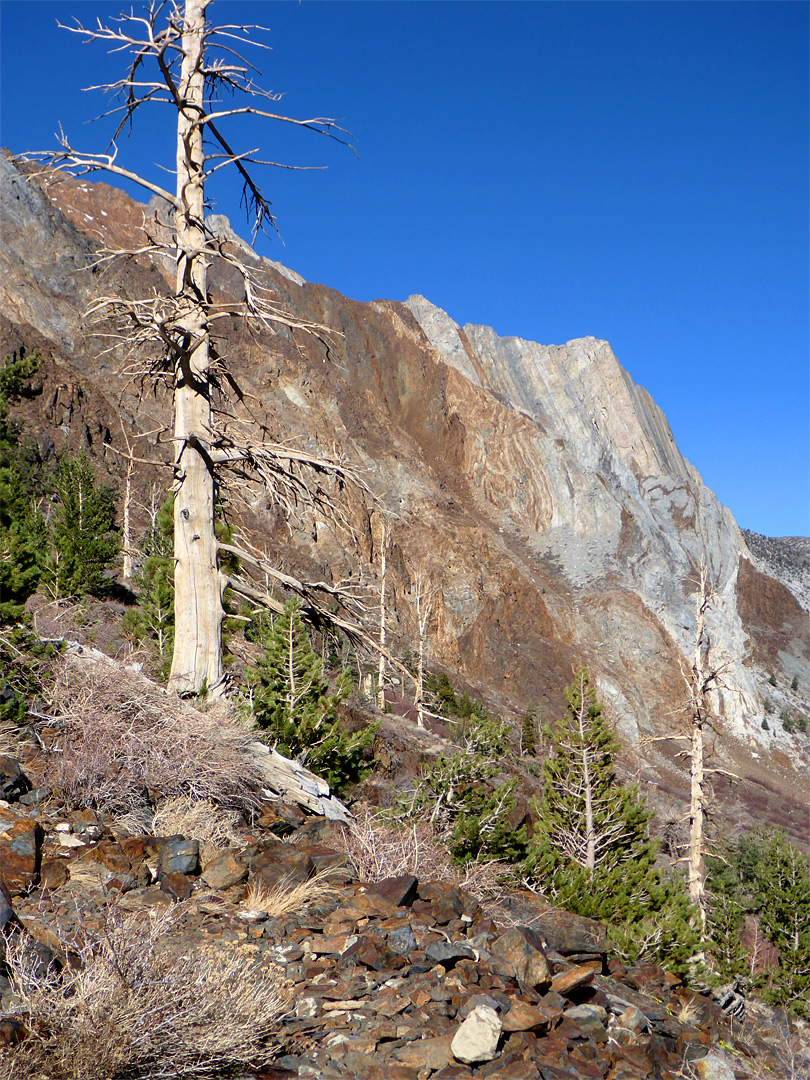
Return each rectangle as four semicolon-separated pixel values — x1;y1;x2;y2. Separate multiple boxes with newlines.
526;669;699;970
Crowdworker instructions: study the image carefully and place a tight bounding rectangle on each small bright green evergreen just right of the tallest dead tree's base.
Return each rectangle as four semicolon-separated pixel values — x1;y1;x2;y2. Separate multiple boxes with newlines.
248;599;379;791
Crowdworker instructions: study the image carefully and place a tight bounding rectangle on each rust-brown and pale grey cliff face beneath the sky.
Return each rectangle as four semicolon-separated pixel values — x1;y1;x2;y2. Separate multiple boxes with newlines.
0;152;810;829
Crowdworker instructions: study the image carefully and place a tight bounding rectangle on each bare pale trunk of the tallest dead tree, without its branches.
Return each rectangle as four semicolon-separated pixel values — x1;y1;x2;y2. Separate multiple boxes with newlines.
170;0;224;694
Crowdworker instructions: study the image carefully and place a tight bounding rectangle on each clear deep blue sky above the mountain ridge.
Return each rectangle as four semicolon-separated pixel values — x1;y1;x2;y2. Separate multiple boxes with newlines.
0;0;810;536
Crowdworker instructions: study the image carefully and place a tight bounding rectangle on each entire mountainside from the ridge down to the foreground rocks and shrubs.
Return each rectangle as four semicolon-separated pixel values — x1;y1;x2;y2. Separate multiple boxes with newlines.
0;154;810;1080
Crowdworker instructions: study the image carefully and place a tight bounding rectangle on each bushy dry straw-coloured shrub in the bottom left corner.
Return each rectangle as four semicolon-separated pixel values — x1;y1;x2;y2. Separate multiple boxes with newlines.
0;908;288;1080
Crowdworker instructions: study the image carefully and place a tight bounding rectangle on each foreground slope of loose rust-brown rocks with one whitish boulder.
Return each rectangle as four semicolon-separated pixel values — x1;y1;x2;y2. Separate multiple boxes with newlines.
0;665;810;1080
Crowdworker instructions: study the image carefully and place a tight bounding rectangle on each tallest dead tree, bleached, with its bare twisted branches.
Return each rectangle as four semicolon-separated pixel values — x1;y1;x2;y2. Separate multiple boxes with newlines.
28;0;354;694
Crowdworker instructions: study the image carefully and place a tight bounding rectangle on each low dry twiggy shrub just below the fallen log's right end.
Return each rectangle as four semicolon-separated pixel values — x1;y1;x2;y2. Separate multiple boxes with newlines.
335;806;505;910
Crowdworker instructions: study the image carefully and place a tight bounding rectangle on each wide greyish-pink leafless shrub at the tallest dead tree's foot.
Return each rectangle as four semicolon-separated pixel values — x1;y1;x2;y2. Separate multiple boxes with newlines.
42;661;261;814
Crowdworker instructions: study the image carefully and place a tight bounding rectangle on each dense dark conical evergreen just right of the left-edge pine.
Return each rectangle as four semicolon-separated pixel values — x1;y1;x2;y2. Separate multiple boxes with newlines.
51;451;120;597
